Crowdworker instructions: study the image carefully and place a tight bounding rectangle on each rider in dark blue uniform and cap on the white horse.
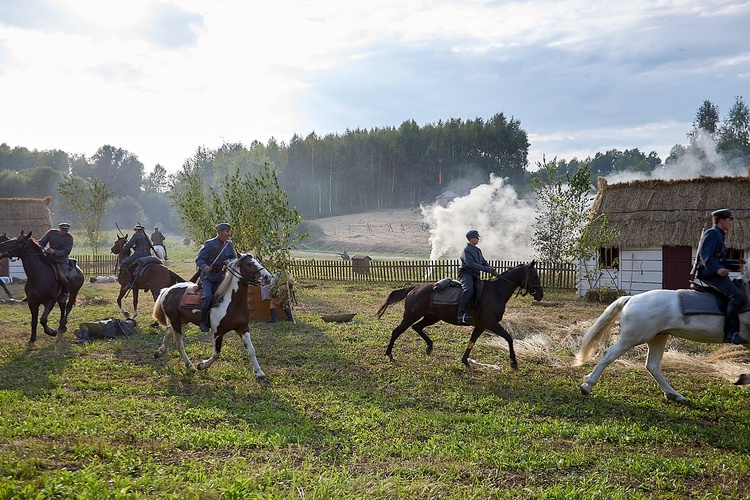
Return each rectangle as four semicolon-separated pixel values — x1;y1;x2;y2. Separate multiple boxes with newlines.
695;208;748;344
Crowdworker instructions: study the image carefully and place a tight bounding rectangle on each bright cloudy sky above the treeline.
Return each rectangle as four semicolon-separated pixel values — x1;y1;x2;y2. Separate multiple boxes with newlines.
0;0;750;172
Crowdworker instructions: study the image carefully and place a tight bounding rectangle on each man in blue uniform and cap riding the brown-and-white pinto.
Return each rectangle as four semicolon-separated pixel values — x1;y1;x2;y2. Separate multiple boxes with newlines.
195;222;237;332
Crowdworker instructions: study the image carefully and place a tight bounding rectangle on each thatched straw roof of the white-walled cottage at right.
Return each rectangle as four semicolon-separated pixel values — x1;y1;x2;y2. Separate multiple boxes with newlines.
591;176;750;248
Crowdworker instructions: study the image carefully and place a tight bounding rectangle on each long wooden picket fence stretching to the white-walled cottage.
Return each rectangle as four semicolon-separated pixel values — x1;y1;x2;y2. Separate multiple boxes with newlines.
289;259;578;290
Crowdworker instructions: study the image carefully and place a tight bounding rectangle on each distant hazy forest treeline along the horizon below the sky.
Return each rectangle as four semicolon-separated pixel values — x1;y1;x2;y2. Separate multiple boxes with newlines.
0;97;750;231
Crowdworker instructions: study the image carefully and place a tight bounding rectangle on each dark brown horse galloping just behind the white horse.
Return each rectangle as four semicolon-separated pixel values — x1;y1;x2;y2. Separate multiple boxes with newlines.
378;262;544;370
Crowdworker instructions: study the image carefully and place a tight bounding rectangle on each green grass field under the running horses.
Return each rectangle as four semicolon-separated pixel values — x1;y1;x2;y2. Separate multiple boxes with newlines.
0;270;750;499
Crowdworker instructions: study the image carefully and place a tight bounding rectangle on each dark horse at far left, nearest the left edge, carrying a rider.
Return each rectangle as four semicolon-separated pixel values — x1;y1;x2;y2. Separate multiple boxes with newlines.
0;231;83;344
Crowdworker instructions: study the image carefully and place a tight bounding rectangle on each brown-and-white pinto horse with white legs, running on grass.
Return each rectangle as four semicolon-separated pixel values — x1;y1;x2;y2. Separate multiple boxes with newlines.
154;254;271;376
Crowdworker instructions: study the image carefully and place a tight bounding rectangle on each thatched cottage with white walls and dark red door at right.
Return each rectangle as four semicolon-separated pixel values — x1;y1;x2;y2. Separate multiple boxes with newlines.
579;176;750;295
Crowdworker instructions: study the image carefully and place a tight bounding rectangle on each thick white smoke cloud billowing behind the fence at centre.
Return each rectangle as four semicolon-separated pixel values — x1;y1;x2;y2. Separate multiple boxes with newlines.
420;175;536;261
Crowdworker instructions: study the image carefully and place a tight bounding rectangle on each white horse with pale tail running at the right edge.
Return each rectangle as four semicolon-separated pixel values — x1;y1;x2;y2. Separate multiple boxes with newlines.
573;265;750;403
